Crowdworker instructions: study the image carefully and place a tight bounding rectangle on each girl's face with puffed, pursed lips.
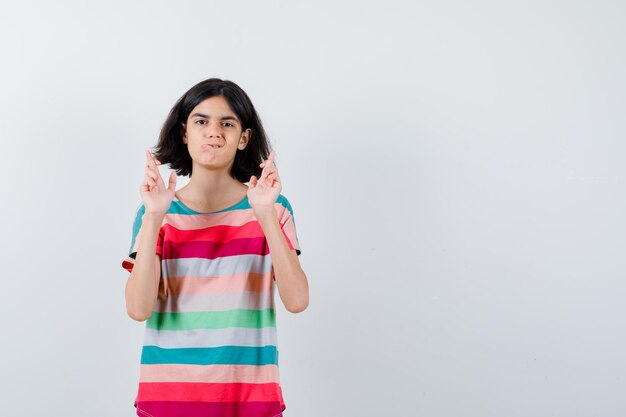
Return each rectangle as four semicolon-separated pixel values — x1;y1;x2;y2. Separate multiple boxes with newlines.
183;96;252;172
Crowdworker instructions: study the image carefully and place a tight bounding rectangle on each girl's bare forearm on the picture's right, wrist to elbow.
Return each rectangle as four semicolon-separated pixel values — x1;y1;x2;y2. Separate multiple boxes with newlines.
255;206;309;313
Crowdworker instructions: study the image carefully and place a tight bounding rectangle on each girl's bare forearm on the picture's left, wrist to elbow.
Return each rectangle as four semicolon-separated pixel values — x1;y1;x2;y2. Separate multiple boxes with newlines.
126;213;164;321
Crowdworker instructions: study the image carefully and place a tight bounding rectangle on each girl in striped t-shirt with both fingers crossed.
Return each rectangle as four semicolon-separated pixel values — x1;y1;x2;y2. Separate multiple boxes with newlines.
122;78;309;417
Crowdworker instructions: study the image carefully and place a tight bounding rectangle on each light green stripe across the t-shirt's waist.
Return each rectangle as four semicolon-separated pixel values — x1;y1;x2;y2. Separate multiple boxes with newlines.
146;308;276;330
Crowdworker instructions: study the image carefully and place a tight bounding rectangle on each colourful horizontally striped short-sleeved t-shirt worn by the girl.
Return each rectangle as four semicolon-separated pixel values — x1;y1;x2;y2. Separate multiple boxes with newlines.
122;194;300;417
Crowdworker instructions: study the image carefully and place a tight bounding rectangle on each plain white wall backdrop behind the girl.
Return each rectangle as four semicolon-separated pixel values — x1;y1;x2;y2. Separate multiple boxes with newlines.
0;0;626;417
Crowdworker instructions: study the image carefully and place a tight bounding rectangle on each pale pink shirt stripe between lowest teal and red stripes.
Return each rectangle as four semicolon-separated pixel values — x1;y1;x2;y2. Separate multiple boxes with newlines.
139;364;280;384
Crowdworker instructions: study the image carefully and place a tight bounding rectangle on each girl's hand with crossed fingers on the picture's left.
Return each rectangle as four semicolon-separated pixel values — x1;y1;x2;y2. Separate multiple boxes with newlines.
139;150;176;214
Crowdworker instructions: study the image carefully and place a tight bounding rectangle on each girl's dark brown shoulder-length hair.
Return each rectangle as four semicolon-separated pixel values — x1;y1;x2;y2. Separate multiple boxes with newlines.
154;78;270;182
